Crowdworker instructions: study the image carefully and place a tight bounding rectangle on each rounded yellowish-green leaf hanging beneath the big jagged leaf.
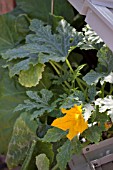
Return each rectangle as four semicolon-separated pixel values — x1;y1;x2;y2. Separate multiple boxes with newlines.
19;64;44;87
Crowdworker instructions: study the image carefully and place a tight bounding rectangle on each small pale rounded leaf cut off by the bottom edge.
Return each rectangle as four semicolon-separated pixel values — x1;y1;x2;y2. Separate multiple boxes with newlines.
36;154;49;170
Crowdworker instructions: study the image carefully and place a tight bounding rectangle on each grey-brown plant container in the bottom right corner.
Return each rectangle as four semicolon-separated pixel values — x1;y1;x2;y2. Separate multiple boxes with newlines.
69;138;113;170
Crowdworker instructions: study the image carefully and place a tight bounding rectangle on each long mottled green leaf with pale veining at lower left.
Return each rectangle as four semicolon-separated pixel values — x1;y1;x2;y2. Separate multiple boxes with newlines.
6;113;37;169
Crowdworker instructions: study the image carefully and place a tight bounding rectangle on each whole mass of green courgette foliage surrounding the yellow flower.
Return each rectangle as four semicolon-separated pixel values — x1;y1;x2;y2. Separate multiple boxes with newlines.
0;0;113;170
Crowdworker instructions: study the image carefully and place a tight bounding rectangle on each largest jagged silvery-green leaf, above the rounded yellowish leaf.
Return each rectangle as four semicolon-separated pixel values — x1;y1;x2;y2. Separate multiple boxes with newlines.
2;19;83;76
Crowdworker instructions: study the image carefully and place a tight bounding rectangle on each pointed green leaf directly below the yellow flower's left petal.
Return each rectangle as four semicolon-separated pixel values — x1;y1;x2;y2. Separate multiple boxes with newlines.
42;127;67;142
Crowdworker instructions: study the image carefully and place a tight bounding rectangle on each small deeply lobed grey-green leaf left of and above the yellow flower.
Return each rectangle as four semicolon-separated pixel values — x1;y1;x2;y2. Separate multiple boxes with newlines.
15;89;56;119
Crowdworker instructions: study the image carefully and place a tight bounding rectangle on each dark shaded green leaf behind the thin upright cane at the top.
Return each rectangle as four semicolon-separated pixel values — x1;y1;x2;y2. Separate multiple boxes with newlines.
17;0;74;22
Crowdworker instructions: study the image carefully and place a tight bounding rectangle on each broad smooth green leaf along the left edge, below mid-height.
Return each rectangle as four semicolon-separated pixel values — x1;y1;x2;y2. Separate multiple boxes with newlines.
0;59;26;153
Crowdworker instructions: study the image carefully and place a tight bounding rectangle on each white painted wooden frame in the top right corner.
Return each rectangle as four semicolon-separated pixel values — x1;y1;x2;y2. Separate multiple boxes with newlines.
68;0;113;51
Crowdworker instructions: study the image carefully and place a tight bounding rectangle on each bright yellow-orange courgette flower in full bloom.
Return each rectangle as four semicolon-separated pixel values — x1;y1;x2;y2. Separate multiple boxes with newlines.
51;105;88;140
